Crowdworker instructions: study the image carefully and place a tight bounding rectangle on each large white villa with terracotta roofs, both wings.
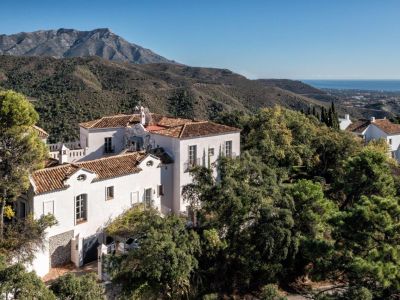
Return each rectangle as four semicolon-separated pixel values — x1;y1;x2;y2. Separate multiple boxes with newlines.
17;108;240;276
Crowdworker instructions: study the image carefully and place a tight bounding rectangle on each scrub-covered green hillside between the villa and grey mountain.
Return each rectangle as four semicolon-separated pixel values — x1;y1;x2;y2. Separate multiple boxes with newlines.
0;56;354;141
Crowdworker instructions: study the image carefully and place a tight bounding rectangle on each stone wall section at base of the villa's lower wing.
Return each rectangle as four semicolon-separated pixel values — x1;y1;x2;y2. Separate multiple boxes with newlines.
49;230;74;268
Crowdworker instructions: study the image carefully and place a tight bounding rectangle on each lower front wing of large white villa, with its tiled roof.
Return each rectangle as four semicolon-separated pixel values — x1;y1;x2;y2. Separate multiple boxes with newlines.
25;152;165;276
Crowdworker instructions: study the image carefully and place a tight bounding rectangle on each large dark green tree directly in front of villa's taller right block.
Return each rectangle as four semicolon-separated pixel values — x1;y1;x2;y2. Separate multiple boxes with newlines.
188;153;297;294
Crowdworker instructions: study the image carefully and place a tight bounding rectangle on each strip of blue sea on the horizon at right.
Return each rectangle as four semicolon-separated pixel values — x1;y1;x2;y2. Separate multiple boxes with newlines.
302;79;400;92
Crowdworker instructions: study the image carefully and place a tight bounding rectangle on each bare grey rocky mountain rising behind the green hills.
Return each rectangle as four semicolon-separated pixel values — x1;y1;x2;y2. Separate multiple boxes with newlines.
0;28;174;64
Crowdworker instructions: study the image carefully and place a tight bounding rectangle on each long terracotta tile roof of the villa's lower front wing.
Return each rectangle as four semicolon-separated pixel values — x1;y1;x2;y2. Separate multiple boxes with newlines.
31;152;147;194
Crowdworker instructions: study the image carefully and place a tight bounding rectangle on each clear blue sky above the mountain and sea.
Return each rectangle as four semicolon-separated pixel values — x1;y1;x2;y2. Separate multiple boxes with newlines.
0;0;400;79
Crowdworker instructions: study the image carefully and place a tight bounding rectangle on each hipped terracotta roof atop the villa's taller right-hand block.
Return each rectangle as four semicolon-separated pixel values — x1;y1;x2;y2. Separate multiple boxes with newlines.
154;121;240;139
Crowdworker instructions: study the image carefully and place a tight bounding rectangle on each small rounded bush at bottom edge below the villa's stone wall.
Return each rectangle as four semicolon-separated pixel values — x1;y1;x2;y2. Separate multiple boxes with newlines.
50;273;104;300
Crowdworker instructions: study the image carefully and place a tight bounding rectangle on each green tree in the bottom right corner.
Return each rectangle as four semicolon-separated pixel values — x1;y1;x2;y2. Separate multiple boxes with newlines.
334;196;400;299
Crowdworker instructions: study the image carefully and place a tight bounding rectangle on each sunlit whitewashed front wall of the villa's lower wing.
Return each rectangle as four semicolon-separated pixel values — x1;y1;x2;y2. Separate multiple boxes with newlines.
28;156;161;276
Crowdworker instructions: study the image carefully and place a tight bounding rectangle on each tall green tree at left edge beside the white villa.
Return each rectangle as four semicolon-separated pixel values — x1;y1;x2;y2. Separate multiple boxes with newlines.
0;91;47;241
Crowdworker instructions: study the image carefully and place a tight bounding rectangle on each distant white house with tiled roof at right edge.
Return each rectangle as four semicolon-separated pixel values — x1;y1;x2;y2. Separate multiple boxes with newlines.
339;115;400;161
